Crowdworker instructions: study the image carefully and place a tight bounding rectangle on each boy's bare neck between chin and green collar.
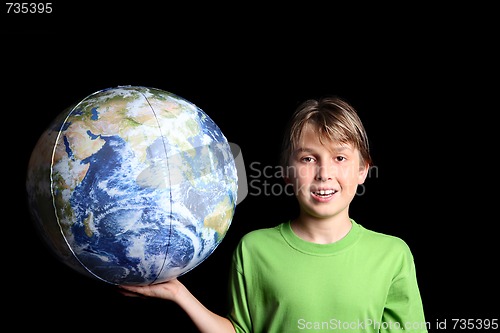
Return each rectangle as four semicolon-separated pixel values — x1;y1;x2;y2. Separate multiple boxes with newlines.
291;216;352;244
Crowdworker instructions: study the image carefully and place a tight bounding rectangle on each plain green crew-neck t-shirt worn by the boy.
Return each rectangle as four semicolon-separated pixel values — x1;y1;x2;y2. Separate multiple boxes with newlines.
228;220;427;333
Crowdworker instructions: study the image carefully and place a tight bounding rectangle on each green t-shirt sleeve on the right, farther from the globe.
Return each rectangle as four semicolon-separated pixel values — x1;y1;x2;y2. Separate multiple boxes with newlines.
380;243;428;333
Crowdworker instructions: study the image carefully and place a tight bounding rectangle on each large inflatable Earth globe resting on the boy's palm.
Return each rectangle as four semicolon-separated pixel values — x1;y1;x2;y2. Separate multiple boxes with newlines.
26;86;238;285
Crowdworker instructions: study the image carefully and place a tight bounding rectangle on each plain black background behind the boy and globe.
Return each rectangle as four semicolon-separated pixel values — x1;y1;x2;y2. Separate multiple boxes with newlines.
1;2;499;332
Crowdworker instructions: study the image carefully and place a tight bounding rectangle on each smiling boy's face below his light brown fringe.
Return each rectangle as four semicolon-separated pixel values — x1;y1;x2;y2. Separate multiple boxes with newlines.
288;125;368;218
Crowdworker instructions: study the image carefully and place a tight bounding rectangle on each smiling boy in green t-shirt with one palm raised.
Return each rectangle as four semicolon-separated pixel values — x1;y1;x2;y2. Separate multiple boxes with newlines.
123;96;427;333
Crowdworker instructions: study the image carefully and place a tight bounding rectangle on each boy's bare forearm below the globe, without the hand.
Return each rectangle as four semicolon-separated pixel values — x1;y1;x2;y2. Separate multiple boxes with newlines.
175;286;236;333
